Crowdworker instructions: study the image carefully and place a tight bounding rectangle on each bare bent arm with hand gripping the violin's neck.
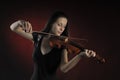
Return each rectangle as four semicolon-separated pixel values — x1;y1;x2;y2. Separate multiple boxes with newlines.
60;49;96;73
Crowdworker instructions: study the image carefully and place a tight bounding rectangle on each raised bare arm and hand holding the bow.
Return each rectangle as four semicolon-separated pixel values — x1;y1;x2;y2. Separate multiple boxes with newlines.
10;20;33;40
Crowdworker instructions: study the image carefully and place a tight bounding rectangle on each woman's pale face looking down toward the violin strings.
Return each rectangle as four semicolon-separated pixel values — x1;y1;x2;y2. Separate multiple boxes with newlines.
50;17;67;36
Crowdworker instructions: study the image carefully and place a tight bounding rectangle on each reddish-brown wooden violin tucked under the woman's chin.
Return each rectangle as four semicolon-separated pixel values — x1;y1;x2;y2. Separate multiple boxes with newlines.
39;32;105;63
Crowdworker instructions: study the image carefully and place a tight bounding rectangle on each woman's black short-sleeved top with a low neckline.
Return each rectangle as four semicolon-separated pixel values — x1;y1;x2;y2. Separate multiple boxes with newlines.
31;32;62;80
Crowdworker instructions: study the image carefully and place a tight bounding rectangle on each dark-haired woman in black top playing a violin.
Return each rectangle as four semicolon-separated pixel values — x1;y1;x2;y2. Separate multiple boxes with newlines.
10;11;96;80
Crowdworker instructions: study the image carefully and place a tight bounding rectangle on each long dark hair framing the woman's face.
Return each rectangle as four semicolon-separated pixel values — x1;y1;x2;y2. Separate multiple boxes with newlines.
42;11;68;36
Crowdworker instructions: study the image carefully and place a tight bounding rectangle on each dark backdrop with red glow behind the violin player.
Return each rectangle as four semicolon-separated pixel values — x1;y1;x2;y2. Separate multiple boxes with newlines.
0;0;120;80
